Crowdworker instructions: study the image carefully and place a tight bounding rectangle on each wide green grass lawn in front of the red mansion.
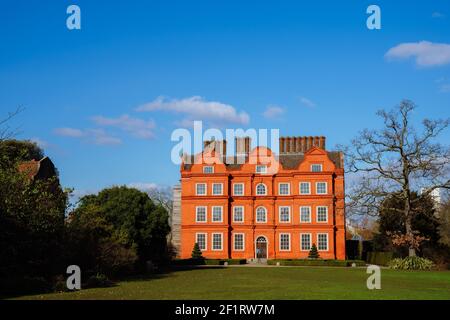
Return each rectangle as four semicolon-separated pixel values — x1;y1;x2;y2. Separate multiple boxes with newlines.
12;267;450;300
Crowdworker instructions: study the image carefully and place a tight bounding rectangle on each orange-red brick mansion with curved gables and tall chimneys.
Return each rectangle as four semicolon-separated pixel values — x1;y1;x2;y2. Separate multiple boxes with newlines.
180;137;345;259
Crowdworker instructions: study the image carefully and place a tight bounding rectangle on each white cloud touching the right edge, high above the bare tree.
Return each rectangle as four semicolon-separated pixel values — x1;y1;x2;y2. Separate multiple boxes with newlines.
385;41;450;67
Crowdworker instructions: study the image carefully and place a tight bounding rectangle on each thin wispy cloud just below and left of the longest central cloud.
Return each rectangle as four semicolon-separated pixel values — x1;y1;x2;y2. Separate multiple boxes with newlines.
92;114;156;139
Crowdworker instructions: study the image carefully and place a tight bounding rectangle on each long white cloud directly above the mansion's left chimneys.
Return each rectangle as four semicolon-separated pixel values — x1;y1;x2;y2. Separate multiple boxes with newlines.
136;96;250;125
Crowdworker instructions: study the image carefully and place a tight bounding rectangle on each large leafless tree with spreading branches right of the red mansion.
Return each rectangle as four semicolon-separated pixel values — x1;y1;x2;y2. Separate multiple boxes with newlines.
345;100;450;256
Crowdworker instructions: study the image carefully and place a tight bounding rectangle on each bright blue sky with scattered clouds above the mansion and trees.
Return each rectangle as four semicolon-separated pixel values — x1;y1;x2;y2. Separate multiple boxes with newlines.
0;0;450;198
